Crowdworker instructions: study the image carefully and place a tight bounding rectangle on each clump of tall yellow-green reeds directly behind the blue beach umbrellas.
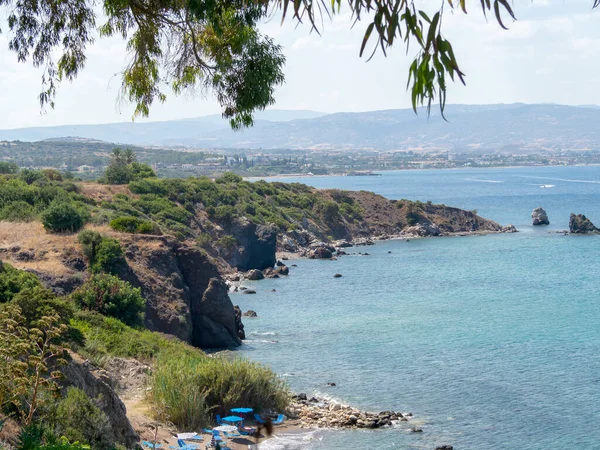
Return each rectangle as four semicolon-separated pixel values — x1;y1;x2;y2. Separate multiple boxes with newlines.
151;354;290;430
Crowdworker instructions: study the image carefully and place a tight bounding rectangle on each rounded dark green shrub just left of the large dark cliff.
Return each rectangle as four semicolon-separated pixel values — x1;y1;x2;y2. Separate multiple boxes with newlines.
71;274;146;326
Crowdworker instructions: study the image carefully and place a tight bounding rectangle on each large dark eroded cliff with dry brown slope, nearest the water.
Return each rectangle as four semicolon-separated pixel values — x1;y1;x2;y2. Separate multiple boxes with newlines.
120;236;241;348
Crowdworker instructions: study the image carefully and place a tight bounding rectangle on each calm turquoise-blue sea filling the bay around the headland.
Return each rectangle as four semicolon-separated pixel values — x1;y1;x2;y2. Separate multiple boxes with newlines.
231;166;600;450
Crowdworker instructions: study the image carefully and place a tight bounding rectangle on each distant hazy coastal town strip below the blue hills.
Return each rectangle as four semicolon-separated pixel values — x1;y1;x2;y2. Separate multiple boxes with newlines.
0;140;600;179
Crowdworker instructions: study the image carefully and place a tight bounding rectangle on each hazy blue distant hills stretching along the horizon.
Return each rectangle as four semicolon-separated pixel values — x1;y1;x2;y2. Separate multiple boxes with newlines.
0;104;600;153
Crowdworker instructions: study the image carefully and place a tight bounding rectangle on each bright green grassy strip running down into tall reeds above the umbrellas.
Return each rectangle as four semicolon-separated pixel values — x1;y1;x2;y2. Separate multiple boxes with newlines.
71;312;290;430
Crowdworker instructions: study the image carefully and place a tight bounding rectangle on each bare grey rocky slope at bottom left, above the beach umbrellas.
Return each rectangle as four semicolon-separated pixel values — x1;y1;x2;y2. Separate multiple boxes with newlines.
62;354;141;449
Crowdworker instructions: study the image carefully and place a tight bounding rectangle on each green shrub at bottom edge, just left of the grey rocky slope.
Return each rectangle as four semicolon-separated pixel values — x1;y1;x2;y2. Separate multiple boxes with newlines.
56;388;114;450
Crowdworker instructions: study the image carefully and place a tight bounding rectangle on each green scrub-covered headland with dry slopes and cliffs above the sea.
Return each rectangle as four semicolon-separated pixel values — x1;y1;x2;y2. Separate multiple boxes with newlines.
0;157;497;450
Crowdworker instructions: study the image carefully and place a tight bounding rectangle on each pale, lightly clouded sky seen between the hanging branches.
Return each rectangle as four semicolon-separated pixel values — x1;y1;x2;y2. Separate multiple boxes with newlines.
0;0;600;129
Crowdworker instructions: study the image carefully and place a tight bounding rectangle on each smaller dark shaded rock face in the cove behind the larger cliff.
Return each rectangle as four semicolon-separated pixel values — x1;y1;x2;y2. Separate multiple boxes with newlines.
227;218;277;271
